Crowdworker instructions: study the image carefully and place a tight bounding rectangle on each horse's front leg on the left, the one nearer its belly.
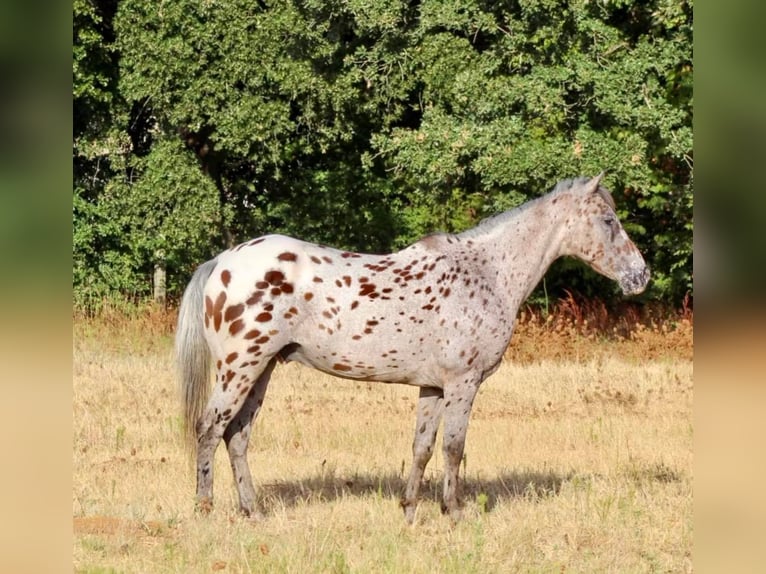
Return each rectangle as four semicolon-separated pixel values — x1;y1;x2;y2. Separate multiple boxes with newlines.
401;388;444;524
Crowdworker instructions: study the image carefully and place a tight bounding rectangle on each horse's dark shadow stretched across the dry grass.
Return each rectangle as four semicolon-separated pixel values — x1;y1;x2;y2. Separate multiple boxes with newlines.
259;470;574;512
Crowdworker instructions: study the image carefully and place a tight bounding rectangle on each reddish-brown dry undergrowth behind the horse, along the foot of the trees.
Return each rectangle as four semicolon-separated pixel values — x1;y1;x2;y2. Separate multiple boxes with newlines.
74;293;694;364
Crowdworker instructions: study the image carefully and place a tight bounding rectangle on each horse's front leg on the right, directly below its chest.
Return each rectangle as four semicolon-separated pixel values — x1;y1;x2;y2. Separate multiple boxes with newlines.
441;378;479;521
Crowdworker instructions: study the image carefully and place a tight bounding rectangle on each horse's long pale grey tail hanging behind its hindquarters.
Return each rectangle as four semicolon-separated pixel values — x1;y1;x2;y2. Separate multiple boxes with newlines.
176;259;217;464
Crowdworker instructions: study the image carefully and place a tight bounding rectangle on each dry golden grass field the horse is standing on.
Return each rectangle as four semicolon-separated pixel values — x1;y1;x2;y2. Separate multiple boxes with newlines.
72;308;693;574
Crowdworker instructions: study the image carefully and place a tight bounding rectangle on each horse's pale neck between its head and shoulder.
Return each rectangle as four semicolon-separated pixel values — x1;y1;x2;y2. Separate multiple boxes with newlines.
462;196;564;309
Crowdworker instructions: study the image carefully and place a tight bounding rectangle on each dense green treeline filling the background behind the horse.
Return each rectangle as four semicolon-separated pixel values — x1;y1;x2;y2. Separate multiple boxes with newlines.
73;0;693;316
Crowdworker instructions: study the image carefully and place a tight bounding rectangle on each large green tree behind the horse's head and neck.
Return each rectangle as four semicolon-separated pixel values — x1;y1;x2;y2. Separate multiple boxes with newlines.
374;0;693;301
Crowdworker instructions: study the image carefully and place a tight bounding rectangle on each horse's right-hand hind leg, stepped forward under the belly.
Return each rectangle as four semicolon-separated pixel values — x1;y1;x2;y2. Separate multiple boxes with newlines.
223;359;276;518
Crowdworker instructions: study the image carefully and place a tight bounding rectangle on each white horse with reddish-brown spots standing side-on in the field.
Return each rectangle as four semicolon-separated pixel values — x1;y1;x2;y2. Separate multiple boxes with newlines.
176;175;649;523
